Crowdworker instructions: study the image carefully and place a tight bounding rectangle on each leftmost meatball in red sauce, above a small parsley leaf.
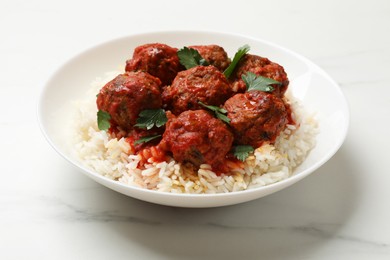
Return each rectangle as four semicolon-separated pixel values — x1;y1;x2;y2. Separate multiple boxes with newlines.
96;71;162;131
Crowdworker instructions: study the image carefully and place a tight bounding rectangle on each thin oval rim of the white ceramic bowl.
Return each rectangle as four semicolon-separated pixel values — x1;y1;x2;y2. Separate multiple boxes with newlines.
36;30;350;207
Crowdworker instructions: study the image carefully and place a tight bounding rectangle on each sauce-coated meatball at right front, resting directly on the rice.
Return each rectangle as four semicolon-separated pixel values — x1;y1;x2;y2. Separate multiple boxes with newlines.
224;90;288;148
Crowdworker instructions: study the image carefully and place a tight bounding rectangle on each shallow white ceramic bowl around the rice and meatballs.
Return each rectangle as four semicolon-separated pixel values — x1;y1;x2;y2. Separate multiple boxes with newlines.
38;31;349;207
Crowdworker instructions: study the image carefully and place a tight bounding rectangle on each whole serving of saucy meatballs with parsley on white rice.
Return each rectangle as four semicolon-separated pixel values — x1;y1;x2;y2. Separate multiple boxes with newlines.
74;43;317;194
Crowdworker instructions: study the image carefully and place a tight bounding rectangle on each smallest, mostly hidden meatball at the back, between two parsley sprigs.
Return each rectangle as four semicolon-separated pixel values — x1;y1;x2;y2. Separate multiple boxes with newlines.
189;45;230;72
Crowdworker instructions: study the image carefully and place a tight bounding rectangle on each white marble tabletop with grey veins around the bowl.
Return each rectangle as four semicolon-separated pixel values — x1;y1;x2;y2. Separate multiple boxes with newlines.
0;0;390;260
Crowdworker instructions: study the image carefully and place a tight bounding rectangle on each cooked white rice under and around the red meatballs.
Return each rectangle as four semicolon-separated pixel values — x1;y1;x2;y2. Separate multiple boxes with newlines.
73;72;318;193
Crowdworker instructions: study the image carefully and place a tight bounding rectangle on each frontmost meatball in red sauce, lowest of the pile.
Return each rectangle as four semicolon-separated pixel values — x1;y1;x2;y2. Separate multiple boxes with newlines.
160;110;233;169
